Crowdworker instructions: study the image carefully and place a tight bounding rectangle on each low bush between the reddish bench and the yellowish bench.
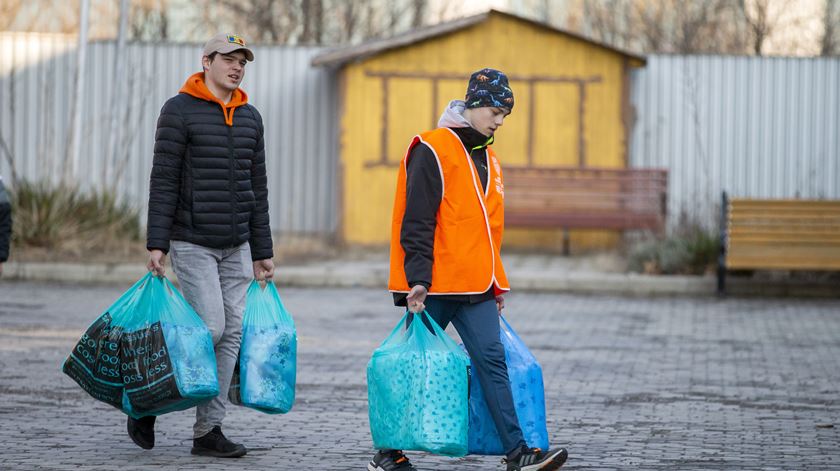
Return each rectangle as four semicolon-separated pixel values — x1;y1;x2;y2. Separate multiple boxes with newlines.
628;224;720;275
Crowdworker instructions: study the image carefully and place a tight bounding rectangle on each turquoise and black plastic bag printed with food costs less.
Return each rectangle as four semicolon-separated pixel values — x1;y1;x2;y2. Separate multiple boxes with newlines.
63;273;219;417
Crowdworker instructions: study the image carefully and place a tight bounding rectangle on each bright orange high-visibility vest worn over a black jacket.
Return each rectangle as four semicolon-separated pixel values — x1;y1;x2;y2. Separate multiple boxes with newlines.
388;128;510;295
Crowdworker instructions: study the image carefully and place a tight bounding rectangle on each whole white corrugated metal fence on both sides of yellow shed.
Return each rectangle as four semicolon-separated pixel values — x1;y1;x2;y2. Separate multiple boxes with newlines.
0;37;840;240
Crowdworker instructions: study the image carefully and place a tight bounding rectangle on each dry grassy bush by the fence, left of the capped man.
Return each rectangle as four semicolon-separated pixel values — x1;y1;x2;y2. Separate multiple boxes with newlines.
10;181;140;252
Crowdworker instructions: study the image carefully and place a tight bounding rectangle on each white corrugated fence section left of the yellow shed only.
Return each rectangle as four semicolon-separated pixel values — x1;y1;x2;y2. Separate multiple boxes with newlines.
0;33;338;235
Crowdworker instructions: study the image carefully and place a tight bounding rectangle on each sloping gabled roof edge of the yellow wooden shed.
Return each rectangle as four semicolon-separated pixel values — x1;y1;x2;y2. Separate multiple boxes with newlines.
312;10;647;67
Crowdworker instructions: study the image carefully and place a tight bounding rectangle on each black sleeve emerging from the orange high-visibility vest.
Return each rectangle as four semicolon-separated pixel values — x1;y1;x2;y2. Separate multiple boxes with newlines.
400;143;443;288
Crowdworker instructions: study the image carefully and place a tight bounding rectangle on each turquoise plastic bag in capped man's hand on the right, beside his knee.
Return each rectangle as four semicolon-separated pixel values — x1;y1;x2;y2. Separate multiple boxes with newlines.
228;280;297;414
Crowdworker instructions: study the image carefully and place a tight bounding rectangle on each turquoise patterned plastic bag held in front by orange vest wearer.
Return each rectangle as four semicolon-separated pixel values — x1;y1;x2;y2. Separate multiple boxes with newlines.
367;312;469;456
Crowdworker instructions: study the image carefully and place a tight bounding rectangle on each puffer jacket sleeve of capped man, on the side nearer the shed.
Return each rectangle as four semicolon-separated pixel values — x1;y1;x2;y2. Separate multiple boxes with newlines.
249;107;274;260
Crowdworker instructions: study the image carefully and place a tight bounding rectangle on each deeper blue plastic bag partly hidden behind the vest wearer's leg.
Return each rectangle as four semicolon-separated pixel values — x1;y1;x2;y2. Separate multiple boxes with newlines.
469;317;548;455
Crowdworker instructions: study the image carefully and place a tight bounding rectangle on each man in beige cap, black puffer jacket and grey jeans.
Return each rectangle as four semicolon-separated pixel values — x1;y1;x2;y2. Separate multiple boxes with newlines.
139;34;274;457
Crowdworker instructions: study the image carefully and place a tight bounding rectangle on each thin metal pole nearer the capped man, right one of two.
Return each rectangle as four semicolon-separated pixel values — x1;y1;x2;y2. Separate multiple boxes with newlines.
102;0;129;190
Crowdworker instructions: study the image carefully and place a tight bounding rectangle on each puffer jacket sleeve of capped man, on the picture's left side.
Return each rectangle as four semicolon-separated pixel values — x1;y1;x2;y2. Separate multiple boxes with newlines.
146;99;187;252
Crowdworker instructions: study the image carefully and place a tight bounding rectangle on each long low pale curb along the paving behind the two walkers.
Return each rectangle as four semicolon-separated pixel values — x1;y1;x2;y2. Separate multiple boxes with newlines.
3;260;840;298
